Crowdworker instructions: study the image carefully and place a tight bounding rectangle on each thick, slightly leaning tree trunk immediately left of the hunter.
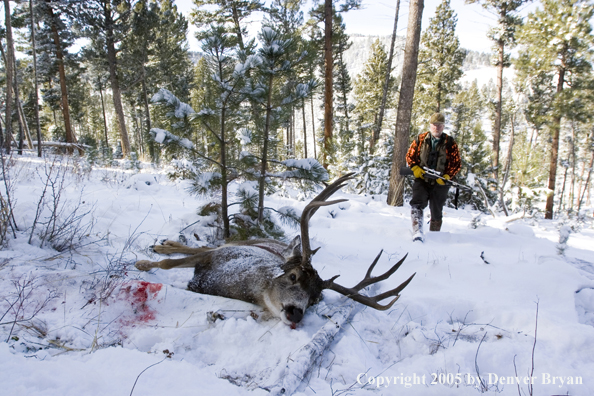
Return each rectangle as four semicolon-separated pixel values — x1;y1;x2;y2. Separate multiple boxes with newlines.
387;0;424;206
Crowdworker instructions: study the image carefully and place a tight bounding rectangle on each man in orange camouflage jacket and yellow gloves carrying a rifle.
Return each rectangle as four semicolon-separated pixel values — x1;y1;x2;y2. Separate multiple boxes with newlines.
406;113;461;242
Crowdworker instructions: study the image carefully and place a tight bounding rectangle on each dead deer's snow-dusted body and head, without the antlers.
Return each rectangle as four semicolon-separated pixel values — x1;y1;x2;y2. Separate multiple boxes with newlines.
136;237;323;325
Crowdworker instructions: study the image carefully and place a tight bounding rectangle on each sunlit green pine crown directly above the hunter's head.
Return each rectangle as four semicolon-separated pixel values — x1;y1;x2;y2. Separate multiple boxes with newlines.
415;0;466;117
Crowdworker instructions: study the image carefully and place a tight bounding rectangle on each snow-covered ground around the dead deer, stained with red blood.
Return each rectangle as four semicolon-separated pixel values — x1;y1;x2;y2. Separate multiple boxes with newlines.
0;155;594;396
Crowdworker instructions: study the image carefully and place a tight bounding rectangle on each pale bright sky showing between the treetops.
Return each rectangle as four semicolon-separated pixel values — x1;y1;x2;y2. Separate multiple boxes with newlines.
175;0;536;52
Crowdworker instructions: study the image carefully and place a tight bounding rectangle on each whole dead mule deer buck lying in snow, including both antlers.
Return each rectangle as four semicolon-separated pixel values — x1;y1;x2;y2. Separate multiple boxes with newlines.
136;173;415;327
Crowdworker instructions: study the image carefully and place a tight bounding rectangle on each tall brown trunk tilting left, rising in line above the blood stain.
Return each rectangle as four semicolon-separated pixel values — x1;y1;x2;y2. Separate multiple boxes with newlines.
105;9;130;158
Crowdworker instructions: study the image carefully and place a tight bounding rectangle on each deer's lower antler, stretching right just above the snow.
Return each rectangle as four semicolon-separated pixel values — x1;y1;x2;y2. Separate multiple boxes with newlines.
323;250;417;311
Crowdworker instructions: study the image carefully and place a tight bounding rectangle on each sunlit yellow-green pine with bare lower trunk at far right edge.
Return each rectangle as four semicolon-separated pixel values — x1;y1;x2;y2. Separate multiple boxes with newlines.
516;0;594;219
